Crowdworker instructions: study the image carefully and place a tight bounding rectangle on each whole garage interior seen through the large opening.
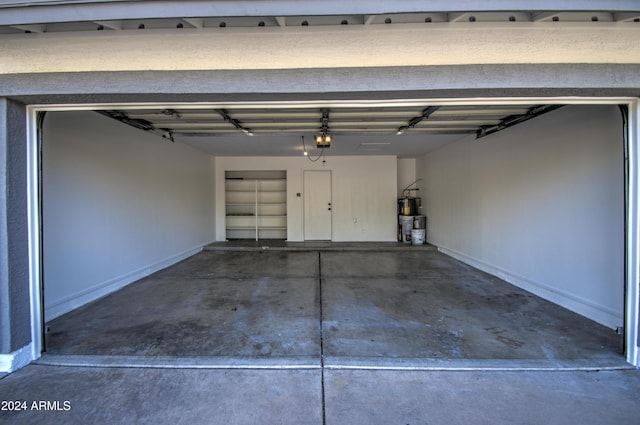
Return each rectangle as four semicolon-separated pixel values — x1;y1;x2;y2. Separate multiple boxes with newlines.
39;102;625;367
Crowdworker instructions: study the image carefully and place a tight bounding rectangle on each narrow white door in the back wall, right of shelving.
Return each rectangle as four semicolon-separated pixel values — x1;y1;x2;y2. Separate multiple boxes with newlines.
303;170;332;241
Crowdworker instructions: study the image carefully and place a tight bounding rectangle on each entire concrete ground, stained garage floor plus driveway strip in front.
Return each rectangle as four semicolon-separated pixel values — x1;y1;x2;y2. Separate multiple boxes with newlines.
0;245;640;425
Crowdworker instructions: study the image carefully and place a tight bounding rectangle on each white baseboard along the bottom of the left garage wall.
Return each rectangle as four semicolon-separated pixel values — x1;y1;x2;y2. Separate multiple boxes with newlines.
44;243;208;322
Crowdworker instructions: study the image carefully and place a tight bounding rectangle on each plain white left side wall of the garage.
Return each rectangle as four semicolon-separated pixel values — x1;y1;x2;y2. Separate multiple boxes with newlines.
43;111;215;320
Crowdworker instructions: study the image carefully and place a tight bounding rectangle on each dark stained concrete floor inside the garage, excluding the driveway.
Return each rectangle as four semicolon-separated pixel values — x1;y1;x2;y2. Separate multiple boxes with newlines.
46;249;624;366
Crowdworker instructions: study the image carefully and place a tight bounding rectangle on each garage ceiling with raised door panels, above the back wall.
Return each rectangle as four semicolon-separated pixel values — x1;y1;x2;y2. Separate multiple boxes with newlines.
98;104;559;158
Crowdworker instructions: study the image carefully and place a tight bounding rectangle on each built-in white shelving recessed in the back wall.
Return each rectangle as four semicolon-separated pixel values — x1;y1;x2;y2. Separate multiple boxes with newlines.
225;171;287;240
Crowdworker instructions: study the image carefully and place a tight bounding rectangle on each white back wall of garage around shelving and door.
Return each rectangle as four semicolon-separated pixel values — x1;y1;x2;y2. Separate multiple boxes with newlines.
216;155;397;242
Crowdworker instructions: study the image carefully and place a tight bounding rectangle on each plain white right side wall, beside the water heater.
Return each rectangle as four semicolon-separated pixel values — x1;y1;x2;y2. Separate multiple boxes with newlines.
418;106;624;327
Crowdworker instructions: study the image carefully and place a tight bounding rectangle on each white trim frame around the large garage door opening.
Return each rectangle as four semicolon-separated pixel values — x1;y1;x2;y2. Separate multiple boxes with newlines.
19;97;640;367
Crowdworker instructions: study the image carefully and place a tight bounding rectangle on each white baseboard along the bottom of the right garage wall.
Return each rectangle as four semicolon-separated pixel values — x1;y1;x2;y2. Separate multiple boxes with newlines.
438;246;624;329
